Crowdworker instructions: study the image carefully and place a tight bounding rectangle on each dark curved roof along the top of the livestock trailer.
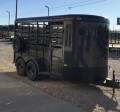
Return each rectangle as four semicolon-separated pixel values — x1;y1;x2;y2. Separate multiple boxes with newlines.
15;14;109;22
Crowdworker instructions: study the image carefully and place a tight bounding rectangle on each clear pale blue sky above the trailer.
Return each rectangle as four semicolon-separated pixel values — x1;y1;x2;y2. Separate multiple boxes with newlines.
0;0;120;29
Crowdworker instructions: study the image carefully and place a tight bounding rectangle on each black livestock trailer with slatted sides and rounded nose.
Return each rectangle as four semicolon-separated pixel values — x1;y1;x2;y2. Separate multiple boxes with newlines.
13;14;109;82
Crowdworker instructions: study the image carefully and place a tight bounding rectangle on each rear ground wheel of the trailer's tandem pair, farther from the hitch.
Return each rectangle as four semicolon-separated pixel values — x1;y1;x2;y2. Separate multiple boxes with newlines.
16;58;26;76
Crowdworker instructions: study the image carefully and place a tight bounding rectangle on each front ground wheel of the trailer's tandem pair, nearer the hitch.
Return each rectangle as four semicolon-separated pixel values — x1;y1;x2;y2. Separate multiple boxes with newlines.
26;61;38;81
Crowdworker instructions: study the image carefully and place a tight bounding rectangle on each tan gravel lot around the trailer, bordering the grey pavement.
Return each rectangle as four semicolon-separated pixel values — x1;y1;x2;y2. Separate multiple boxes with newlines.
0;39;120;112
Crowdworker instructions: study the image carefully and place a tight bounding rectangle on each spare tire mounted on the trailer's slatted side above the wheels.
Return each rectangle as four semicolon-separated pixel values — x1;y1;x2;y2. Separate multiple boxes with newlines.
13;37;24;52
